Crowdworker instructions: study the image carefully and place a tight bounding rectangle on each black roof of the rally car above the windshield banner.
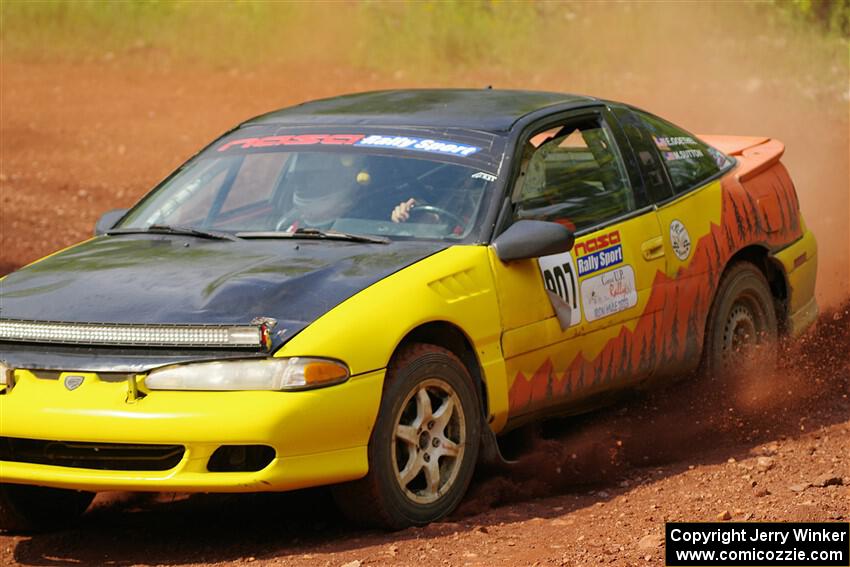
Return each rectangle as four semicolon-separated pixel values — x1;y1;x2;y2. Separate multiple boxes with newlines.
243;88;600;132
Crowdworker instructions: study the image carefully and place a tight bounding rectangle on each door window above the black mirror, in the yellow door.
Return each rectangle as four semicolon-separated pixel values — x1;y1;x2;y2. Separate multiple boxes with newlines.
512;117;635;231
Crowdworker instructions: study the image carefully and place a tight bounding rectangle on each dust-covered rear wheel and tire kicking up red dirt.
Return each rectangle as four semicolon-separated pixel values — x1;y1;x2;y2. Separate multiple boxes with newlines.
703;262;777;376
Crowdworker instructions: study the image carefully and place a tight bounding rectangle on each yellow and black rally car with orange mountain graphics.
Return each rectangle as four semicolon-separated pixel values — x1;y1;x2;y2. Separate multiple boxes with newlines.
0;89;817;530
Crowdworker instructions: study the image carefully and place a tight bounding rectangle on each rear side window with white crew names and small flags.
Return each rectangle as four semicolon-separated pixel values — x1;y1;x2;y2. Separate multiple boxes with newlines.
637;112;732;193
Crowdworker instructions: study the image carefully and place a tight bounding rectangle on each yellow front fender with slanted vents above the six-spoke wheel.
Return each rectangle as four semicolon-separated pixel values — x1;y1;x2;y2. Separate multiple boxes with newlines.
275;246;508;431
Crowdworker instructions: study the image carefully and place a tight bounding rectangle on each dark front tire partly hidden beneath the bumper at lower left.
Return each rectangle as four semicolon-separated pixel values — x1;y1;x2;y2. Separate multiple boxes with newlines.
0;484;94;533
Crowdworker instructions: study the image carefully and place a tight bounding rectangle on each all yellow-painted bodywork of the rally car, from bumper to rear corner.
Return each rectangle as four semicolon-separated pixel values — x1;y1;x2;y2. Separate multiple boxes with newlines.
0;175;817;492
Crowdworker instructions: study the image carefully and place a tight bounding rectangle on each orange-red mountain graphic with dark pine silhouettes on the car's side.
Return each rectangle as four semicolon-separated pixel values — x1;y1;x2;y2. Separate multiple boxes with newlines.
508;162;802;416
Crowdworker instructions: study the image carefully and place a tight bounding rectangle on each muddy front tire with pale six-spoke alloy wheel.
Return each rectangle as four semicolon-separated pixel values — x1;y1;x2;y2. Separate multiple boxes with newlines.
334;343;481;529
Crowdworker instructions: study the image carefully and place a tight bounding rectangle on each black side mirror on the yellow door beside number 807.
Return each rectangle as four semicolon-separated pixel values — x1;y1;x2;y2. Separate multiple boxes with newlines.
486;220;576;262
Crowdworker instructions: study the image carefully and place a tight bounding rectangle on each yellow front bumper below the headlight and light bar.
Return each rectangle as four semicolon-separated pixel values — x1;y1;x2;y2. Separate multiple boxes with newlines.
0;370;384;492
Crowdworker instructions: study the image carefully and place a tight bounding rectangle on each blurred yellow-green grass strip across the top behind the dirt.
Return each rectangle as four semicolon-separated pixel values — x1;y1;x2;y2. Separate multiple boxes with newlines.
0;0;850;70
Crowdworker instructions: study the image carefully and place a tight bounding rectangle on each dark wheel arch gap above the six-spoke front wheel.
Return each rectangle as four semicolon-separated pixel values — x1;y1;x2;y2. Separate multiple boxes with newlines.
389;321;490;421
